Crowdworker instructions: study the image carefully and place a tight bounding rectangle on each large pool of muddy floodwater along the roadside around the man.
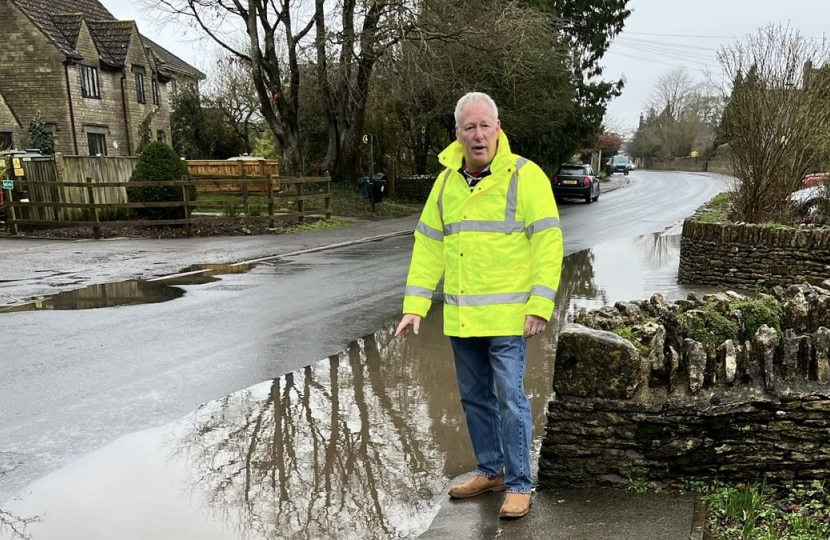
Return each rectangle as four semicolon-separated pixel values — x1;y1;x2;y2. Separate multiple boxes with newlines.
0;231;720;540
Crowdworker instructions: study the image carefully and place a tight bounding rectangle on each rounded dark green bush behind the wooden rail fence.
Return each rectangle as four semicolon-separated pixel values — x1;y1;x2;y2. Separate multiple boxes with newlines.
127;141;196;223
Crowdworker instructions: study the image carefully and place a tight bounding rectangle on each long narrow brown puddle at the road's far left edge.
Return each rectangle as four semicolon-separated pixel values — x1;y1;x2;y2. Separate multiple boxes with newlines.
0;280;185;313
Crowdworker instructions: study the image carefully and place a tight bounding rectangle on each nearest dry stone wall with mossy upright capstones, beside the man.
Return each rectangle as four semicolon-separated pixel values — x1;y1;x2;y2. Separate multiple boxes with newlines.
539;280;830;488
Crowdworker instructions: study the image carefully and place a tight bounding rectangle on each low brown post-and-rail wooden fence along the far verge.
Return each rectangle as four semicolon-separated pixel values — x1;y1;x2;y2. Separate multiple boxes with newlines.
2;174;331;238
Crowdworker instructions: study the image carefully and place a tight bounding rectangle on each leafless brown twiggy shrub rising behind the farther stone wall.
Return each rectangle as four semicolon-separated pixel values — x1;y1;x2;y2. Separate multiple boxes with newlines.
718;25;830;223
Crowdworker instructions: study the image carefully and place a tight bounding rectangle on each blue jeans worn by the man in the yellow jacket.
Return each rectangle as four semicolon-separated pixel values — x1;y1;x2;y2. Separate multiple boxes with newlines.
450;336;532;493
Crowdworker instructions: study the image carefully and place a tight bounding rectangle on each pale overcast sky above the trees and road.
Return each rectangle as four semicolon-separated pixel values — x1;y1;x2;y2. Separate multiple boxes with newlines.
101;0;830;134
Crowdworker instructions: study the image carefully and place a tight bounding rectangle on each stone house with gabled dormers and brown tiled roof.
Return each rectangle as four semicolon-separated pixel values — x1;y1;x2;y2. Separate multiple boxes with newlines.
0;0;205;156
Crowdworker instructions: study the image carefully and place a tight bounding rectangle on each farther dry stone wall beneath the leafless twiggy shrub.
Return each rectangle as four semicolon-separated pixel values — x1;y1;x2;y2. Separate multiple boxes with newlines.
678;218;830;288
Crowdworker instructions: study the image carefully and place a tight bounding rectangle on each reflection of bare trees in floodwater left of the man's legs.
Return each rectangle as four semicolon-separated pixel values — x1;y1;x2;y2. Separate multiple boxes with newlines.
171;325;446;539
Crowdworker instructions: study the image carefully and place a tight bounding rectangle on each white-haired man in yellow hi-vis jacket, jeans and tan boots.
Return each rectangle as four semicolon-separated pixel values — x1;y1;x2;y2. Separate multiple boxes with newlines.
395;92;562;518
